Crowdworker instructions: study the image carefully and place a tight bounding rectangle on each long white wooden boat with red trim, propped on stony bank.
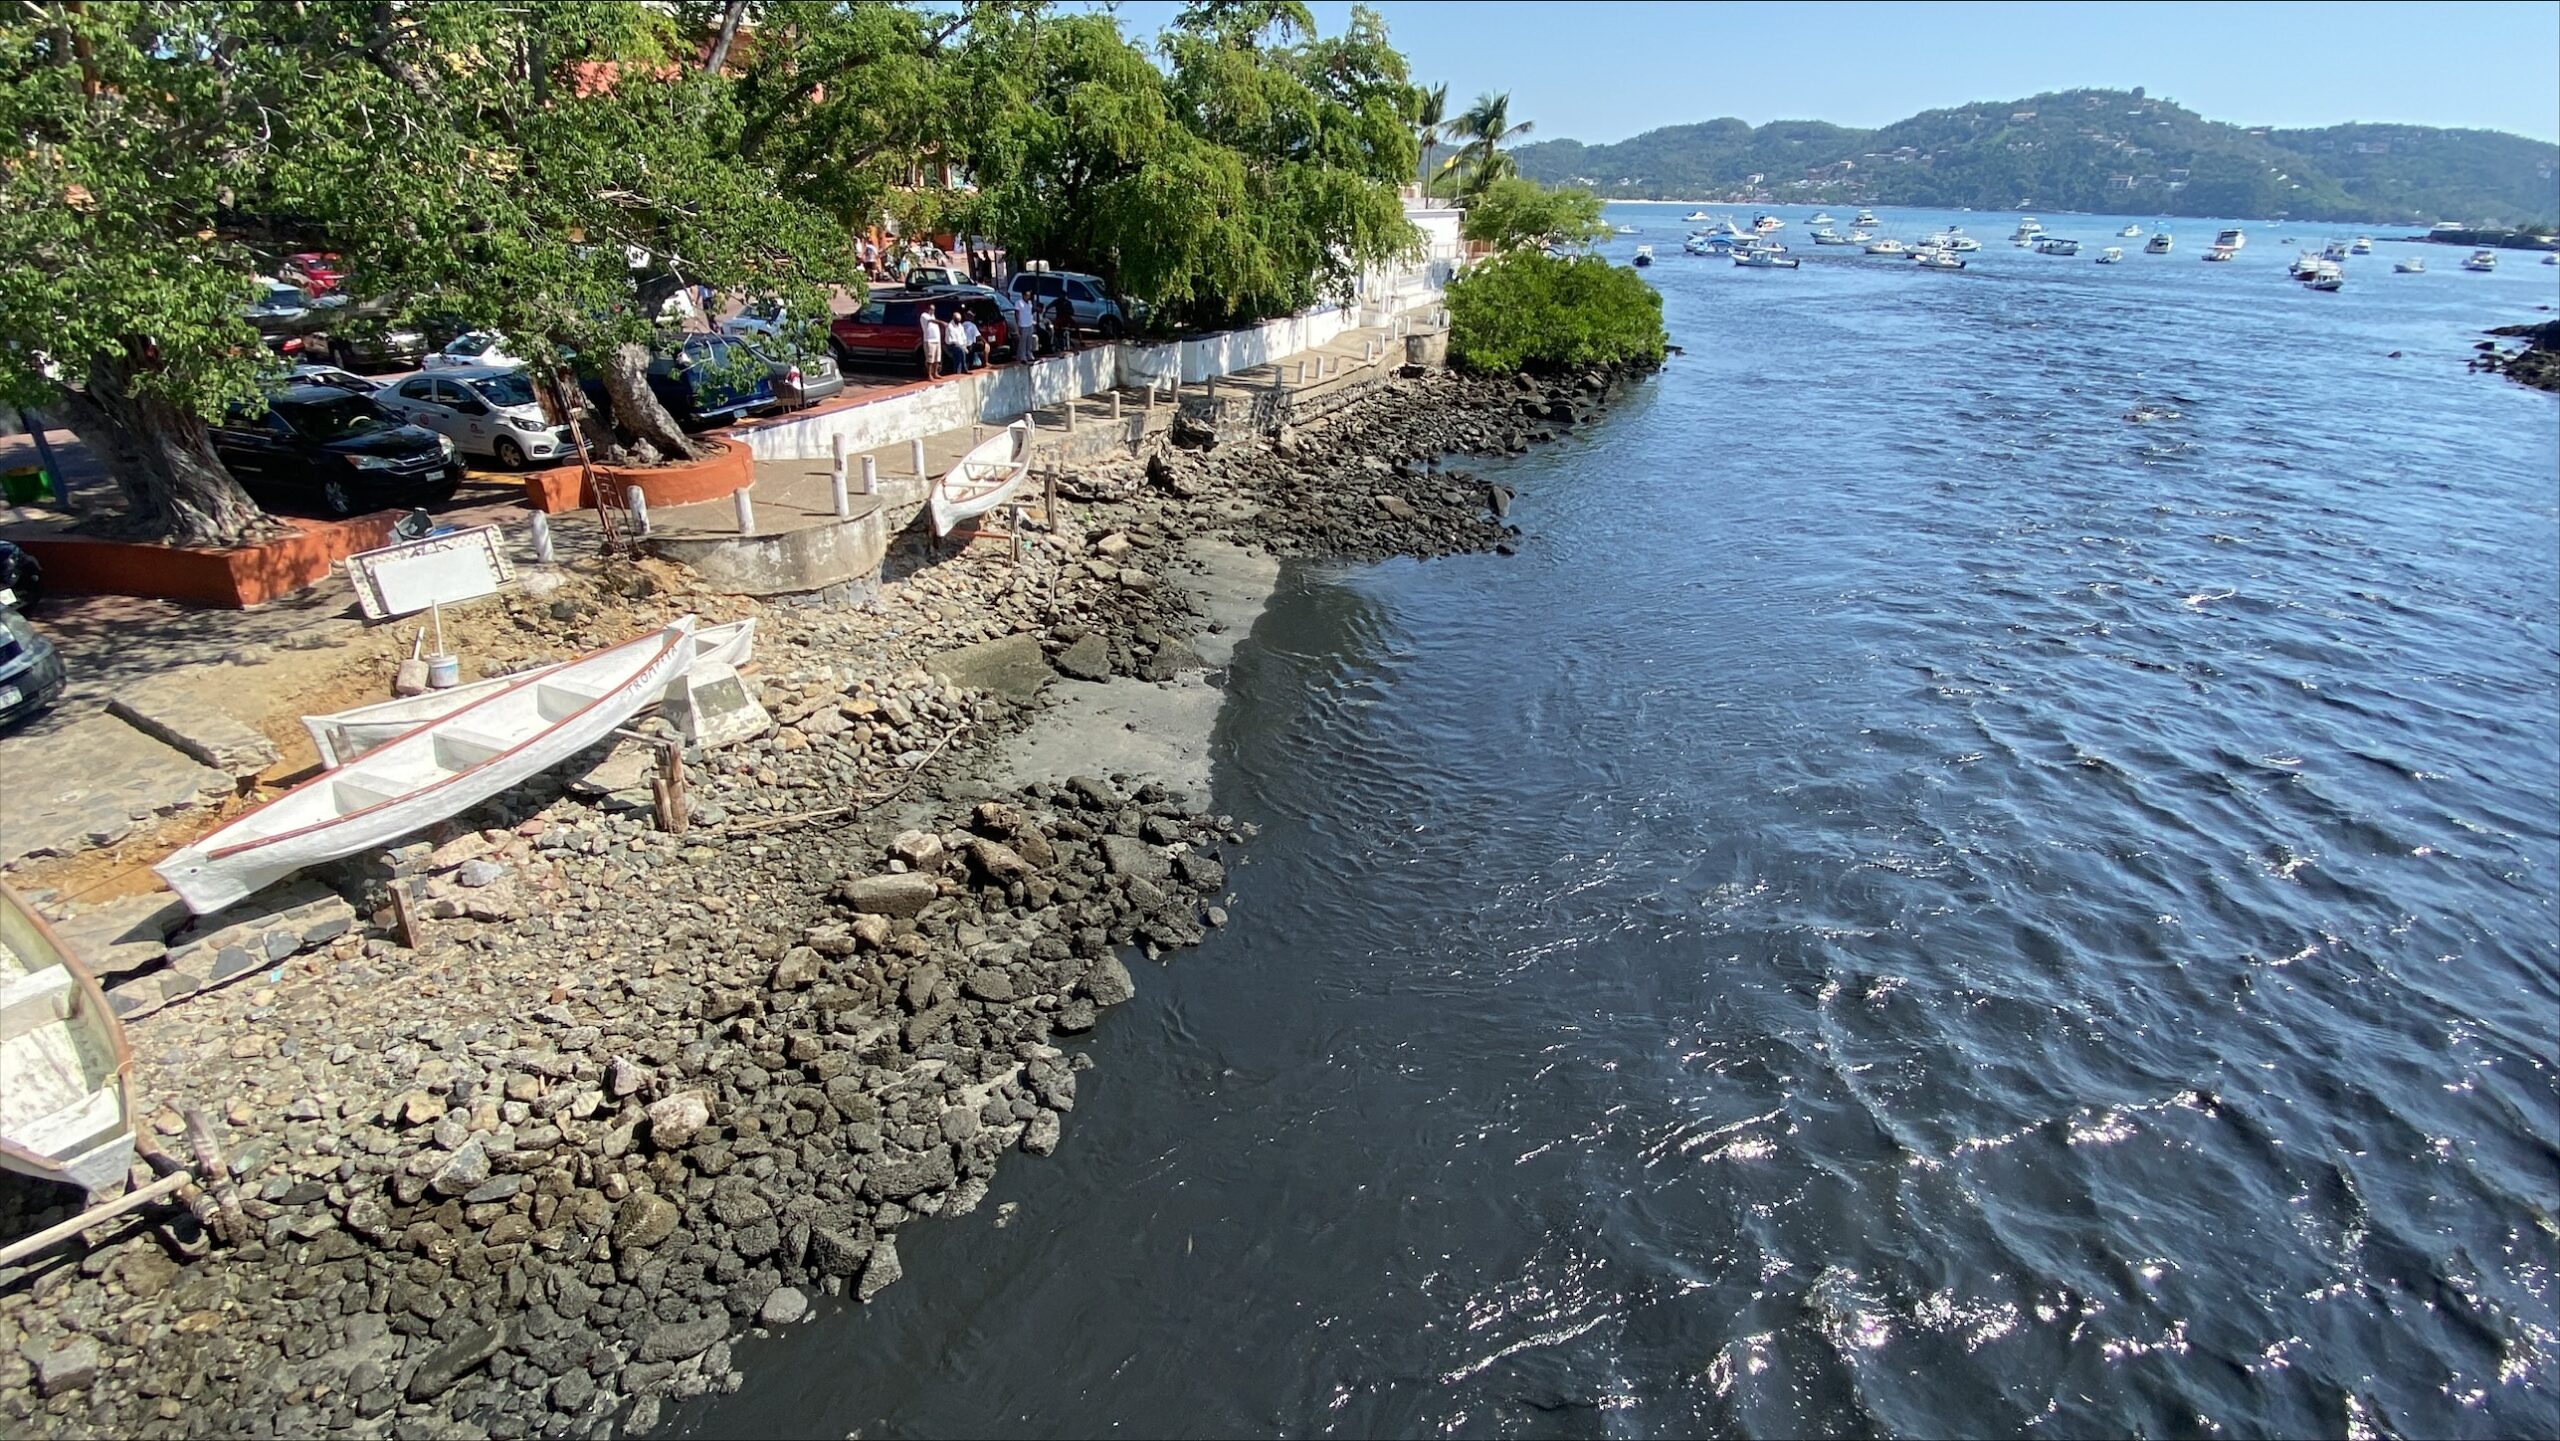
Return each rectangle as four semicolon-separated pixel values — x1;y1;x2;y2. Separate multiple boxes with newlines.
154;617;694;916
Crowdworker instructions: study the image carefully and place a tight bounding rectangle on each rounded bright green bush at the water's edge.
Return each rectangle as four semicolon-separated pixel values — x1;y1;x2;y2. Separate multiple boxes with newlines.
1449;251;1672;374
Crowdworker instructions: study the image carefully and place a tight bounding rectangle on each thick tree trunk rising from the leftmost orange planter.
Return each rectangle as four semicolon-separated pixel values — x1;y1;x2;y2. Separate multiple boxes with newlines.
56;358;276;545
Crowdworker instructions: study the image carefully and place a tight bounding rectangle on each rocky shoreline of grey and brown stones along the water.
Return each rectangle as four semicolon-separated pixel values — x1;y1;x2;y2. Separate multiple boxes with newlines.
0;355;1628;1436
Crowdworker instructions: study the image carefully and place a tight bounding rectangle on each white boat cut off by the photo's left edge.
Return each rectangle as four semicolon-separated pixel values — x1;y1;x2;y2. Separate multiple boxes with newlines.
0;886;133;1190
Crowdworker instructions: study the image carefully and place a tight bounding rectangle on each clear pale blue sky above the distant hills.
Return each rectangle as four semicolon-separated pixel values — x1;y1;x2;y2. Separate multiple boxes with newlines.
1119;0;2560;143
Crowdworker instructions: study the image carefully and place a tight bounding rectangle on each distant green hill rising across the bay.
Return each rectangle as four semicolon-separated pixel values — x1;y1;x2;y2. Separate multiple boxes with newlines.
1513;90;2560;225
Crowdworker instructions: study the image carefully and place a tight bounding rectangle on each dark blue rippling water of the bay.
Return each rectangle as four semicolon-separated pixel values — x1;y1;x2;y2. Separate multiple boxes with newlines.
678;207;2560;1436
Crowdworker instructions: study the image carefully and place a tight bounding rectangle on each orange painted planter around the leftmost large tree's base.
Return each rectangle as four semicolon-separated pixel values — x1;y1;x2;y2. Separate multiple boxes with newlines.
13;509;404;609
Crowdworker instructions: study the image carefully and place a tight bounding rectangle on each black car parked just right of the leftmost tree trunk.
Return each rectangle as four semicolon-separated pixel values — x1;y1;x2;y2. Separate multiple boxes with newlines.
212;386;463;514
